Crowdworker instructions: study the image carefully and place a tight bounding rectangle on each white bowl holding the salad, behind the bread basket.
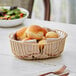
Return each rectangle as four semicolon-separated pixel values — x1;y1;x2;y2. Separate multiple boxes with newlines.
0;6;29;27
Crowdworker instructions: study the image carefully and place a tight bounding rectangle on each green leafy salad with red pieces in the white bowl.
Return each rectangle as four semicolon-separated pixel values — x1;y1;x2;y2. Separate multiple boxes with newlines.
0;6;26;20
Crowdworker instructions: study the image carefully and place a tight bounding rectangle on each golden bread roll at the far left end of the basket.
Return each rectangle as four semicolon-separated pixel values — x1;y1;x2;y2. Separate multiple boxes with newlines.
16;27;27;40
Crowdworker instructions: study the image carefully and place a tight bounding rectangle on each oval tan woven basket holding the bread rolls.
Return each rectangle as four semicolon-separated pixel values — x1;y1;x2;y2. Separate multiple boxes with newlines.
9;30;67;59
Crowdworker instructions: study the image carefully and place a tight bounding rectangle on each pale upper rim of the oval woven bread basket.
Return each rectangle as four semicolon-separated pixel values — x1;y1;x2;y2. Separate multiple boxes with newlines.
9;29;68;45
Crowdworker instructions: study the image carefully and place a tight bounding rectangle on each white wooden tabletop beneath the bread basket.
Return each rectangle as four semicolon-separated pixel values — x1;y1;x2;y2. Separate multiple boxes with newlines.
0;19;76;76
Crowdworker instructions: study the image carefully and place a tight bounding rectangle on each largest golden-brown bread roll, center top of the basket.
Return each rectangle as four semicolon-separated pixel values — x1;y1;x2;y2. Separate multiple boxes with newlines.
26;25;46;40
